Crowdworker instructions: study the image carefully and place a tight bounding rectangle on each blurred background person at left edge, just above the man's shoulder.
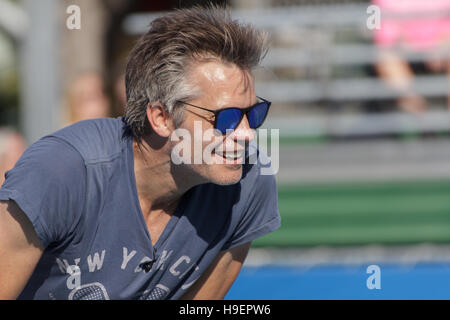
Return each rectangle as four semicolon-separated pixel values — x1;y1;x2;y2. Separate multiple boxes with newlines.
0;128;26;186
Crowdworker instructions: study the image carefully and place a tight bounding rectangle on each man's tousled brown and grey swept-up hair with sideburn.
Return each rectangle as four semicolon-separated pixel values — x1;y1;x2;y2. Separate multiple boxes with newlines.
125;5;267;142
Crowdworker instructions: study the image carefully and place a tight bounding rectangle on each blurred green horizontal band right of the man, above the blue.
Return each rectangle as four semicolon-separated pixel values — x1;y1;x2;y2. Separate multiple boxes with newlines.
253;180;450;247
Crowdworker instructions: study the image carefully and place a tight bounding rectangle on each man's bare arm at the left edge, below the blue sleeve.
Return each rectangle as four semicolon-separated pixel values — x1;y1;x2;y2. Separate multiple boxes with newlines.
0;201;44;300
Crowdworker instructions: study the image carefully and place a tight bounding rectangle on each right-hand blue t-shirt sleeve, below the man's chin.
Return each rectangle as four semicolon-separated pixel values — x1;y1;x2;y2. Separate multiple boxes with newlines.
222;160;281;250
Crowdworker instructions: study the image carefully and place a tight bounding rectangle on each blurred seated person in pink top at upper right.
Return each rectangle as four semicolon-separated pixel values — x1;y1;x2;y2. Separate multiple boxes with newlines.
372;0;450;112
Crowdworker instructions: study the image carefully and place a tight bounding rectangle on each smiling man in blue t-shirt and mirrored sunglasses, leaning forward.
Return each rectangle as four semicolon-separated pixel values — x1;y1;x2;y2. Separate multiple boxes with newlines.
0;7;280;299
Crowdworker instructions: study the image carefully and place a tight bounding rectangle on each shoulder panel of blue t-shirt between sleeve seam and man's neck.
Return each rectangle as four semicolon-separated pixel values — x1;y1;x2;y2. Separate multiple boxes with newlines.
47;118;127;163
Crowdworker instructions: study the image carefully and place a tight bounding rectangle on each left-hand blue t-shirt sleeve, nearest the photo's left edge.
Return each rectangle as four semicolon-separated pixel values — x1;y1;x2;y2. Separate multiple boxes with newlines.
0;136;86;247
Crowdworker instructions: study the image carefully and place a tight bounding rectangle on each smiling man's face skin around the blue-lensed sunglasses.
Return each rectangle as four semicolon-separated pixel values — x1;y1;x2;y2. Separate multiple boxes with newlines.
171;62;256;185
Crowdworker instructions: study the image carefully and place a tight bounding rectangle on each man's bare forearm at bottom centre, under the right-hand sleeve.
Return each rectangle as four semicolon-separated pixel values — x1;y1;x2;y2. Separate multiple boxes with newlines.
181;242;251;300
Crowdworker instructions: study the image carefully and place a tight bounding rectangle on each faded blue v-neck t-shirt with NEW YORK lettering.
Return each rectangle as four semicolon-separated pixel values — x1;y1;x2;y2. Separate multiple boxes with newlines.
0;118;280;299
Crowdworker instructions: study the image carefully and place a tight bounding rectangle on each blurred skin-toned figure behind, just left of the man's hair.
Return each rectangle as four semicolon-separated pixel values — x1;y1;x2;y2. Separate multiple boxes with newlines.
68;72;111;123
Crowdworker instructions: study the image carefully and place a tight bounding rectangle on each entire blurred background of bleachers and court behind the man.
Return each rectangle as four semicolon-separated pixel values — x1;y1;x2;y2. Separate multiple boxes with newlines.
0;0;450;299
